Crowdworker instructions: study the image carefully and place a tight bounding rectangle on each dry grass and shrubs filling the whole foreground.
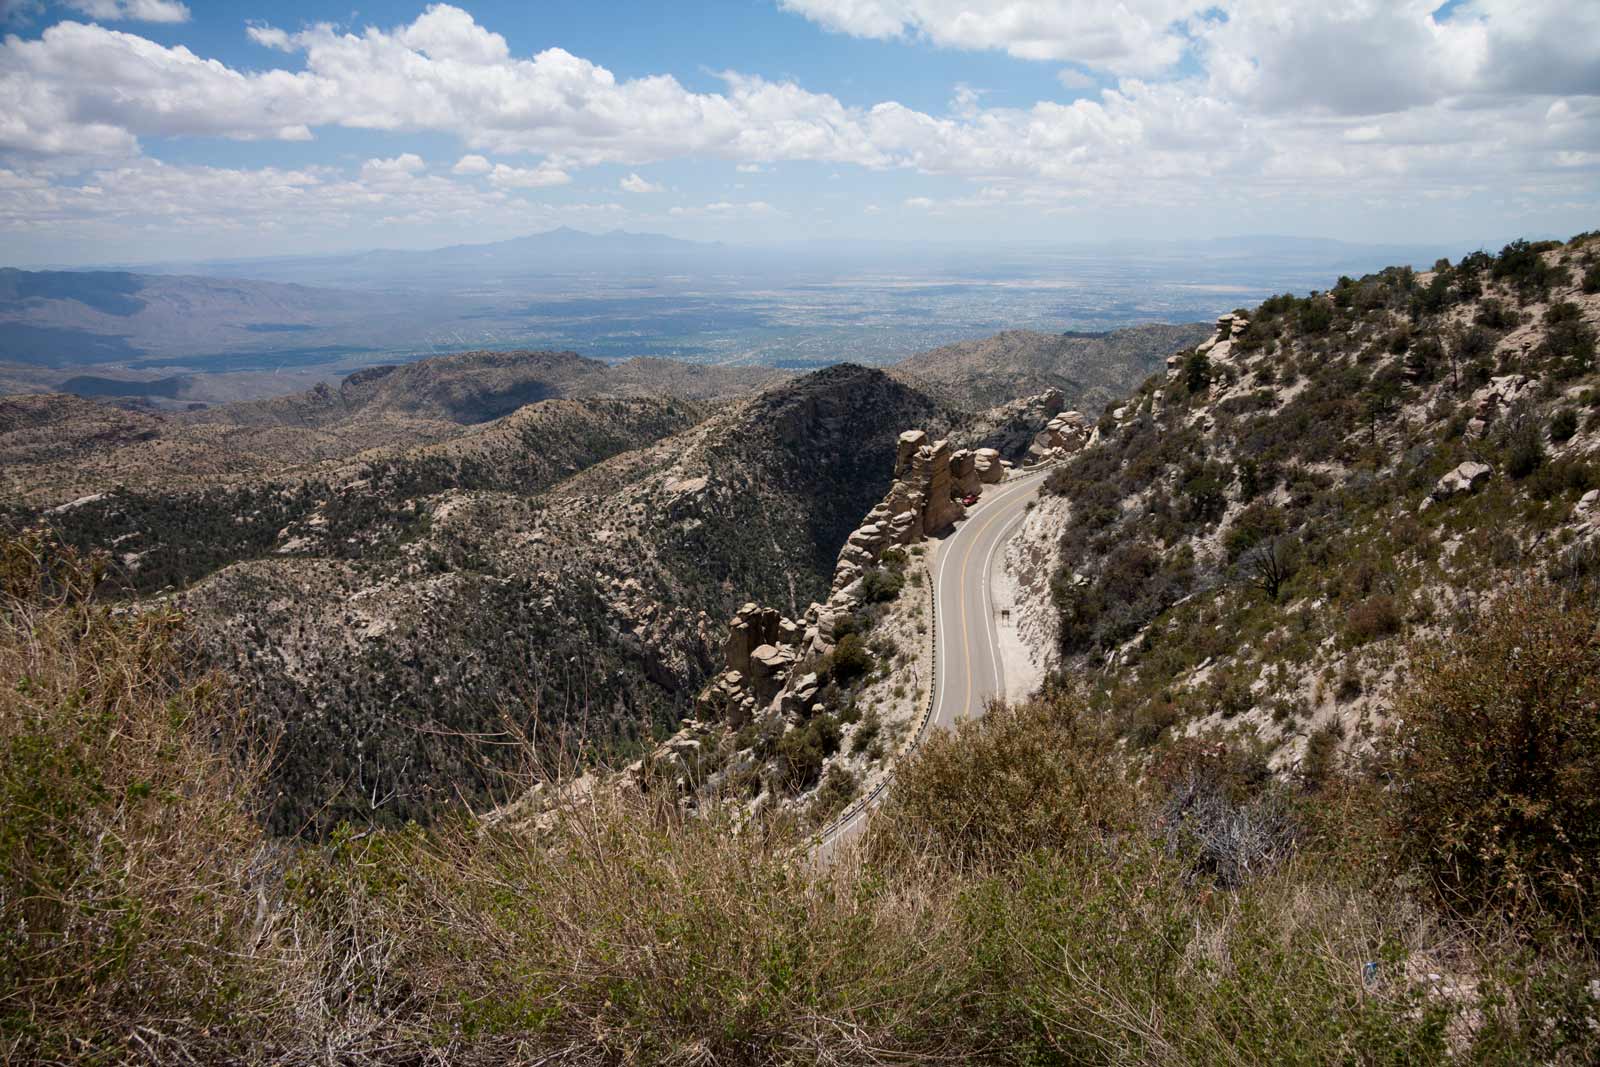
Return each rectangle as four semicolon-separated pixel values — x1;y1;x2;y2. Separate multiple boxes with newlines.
0;534;1600;1064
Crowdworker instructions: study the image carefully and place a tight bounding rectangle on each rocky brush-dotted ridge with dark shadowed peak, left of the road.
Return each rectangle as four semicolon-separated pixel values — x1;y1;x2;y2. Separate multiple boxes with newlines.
172;365;947;832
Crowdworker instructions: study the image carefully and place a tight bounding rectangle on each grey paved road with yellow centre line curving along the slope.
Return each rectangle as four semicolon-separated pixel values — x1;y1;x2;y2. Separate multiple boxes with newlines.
814;470;1046;862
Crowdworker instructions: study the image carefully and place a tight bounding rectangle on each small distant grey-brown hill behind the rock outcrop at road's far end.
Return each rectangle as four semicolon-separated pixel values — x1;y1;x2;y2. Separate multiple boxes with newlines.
890;323;1210;414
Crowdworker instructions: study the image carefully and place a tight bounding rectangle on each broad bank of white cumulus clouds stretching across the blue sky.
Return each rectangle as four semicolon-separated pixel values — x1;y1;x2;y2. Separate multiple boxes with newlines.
0;0;1600;247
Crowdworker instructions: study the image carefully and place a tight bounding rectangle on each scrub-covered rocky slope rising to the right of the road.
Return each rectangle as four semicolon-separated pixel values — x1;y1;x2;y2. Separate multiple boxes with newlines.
1008;235;1600;777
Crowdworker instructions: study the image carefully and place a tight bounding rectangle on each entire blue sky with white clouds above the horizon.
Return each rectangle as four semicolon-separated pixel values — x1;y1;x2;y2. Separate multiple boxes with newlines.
0;0;1600;262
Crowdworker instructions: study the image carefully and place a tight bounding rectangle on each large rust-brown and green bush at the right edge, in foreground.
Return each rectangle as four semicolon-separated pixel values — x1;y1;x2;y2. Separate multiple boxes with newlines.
1390;589;1600;931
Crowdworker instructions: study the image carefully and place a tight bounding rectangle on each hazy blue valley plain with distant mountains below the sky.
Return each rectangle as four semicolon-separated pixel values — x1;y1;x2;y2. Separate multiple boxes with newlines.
0;229;1462;405
